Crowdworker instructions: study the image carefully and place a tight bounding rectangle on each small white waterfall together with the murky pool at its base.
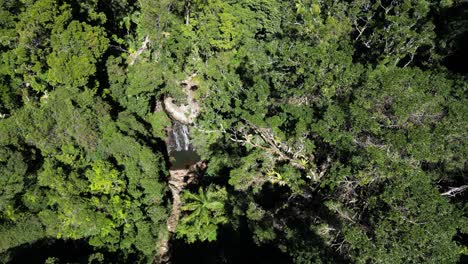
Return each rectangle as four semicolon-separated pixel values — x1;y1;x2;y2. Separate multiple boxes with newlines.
167;121;200;170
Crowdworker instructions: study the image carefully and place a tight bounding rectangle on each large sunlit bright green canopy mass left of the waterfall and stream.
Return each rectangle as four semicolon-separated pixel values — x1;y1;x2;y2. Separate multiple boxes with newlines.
0;86;166;258
